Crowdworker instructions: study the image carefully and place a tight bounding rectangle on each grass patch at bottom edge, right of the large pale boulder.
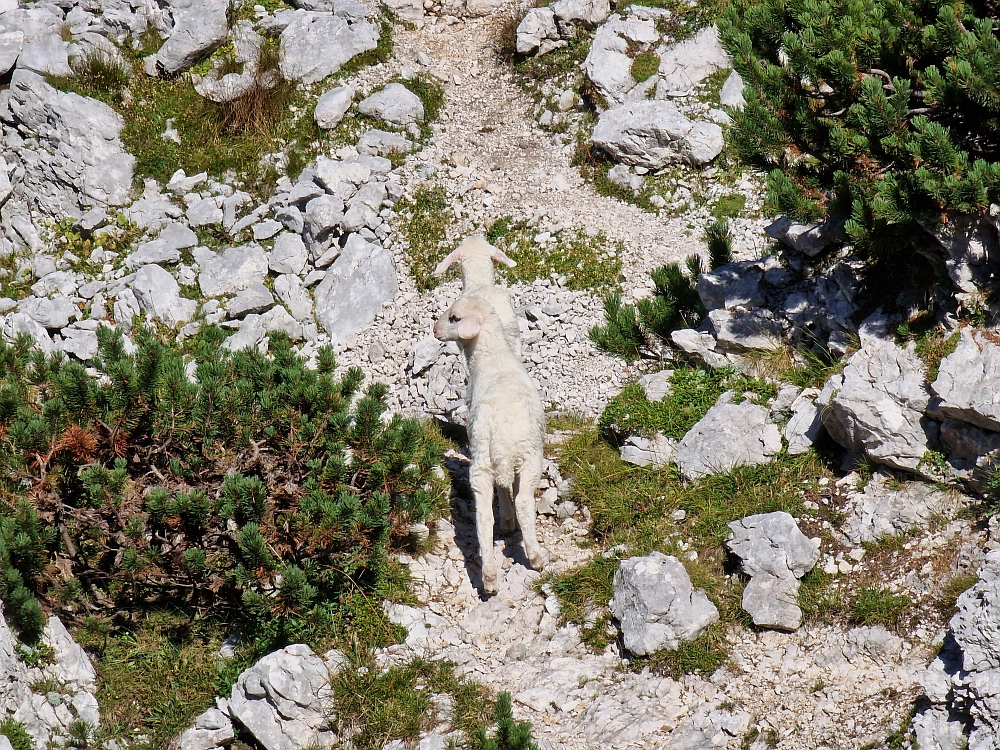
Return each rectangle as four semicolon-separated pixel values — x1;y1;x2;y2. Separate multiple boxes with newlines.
333;659;493;750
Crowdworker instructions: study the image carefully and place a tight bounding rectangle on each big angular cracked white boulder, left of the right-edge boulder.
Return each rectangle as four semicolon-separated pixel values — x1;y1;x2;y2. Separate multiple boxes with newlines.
816;333;934;471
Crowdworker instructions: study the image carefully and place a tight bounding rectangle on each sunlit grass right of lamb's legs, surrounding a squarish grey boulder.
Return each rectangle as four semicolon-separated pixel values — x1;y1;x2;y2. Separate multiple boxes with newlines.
549;429;824;656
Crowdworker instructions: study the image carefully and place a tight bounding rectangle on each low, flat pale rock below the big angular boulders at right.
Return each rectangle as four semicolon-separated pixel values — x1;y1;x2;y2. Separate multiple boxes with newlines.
841;472;970;544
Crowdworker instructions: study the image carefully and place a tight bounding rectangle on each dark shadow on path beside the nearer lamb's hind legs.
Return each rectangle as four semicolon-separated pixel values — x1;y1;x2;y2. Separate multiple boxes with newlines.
444;445;532;601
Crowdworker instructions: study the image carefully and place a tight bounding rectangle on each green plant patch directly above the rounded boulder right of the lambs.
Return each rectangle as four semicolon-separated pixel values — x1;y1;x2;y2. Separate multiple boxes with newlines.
599;368;777;440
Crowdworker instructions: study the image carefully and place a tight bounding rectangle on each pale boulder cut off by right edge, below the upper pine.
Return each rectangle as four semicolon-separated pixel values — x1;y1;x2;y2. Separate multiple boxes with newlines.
931;328;1000;432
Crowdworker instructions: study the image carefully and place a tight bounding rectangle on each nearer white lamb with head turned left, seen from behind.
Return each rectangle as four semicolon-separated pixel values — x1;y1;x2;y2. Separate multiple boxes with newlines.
434;296;545;594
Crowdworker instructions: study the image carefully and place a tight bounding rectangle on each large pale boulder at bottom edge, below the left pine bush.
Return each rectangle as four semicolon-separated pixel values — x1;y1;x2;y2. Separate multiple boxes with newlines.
229;644;336;750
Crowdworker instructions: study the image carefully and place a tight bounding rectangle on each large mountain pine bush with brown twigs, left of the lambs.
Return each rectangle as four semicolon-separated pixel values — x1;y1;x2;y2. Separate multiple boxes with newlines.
0;329;447;643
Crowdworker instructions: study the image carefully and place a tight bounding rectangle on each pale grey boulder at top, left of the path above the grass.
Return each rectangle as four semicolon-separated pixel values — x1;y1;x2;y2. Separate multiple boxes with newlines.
279;10;379;83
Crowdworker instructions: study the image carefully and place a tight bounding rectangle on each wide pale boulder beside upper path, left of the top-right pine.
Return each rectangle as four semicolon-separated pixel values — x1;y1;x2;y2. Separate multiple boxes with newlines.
591;100;724;169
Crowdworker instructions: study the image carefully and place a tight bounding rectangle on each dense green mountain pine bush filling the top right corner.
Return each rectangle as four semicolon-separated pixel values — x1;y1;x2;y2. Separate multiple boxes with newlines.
719;0;1000;256
